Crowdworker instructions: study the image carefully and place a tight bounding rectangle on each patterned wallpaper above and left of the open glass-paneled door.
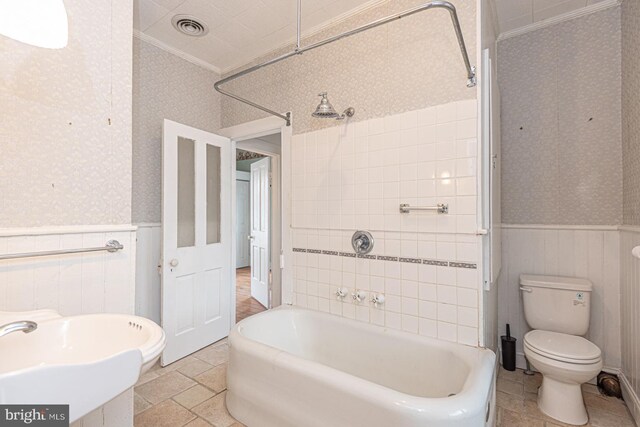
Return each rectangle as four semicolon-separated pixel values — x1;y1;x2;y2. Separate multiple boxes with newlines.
133;38;220;223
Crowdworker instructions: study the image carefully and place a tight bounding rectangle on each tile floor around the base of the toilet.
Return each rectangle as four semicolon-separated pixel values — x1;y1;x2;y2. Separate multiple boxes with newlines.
497;368;635;427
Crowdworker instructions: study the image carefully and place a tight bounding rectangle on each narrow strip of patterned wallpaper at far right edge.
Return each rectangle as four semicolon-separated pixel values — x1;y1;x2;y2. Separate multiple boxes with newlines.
622;0;640;225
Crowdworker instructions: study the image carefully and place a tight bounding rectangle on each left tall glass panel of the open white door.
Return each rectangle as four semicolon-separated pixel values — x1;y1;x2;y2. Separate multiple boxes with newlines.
178;136;196;248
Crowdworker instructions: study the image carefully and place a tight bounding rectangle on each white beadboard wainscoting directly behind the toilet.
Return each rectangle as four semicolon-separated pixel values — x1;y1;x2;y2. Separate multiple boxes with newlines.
498;226;621;370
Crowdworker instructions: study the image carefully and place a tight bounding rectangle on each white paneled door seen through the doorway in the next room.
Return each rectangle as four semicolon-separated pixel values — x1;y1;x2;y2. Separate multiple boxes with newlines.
249;157;271;308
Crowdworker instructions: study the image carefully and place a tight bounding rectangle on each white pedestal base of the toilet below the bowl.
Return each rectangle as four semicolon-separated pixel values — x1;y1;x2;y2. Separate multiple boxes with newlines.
538;375;589;425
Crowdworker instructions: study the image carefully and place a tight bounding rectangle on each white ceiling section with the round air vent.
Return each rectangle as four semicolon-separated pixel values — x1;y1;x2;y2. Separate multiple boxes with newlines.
133;0;380;72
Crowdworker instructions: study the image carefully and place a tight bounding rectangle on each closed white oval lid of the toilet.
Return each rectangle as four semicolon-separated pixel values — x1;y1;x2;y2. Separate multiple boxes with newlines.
524;330;602;363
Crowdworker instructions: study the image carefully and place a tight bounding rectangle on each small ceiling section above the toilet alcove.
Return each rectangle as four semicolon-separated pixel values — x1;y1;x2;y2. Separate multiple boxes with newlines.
494;0;604;33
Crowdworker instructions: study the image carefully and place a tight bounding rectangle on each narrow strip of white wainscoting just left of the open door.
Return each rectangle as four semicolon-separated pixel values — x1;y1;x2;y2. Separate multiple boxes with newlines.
135;223;162;324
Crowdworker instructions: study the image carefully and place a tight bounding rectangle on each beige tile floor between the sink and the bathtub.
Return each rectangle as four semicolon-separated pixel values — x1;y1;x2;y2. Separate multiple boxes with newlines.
134;339;242;427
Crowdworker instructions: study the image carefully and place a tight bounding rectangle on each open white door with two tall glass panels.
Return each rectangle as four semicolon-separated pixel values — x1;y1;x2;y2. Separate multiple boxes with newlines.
162;120;231;366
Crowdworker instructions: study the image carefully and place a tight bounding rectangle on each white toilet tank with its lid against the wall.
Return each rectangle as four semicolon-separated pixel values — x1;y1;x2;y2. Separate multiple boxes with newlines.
520;274;593;336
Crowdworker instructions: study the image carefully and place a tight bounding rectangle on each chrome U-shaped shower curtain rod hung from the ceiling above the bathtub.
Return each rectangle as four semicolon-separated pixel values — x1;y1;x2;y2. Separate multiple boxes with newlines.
213;1;476;126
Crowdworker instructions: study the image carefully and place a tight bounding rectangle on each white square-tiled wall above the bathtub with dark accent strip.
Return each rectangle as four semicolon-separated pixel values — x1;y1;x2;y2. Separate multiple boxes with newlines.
292;100;481;345
